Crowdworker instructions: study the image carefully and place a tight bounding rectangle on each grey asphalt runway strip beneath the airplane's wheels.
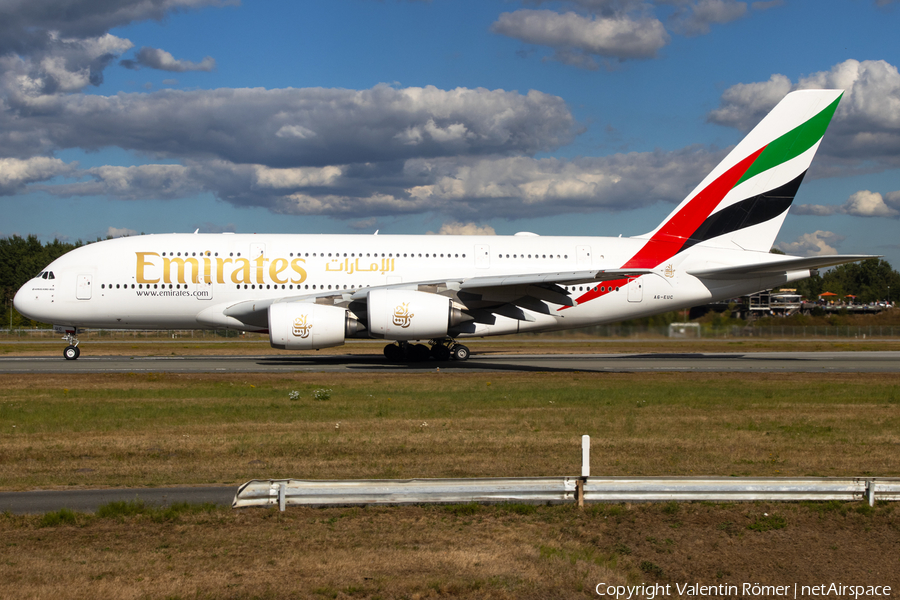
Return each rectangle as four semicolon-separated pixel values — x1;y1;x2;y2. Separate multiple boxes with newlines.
0;352;900;373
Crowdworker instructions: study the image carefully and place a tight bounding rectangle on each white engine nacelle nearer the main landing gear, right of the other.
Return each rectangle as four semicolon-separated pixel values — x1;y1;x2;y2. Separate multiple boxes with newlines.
367;290;472;340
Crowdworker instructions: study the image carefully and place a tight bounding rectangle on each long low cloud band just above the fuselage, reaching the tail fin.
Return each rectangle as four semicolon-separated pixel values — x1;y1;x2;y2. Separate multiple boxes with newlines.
20;147;724;220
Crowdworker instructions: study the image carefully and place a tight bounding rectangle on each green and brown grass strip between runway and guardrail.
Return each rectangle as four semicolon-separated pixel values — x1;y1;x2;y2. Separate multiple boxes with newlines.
0;372;900;489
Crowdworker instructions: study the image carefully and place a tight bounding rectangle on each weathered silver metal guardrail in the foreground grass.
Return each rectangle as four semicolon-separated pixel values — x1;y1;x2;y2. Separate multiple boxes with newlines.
232;477;900;510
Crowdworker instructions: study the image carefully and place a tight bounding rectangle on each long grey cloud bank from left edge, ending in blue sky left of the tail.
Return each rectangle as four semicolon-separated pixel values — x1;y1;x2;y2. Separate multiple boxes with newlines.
0;85;576;167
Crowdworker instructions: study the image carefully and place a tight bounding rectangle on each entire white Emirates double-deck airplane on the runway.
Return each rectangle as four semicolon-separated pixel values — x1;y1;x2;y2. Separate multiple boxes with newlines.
14;90;870;361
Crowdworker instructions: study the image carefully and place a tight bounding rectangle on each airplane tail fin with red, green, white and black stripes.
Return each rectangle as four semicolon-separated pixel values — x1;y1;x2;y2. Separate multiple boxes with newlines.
624;90;843;268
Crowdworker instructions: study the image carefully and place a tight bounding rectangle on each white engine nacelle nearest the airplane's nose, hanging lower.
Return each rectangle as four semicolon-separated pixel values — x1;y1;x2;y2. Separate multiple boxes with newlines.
269;302;359;350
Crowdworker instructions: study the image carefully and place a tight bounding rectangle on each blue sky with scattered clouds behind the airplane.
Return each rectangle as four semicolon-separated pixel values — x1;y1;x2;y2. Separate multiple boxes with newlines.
0;0;900;266
